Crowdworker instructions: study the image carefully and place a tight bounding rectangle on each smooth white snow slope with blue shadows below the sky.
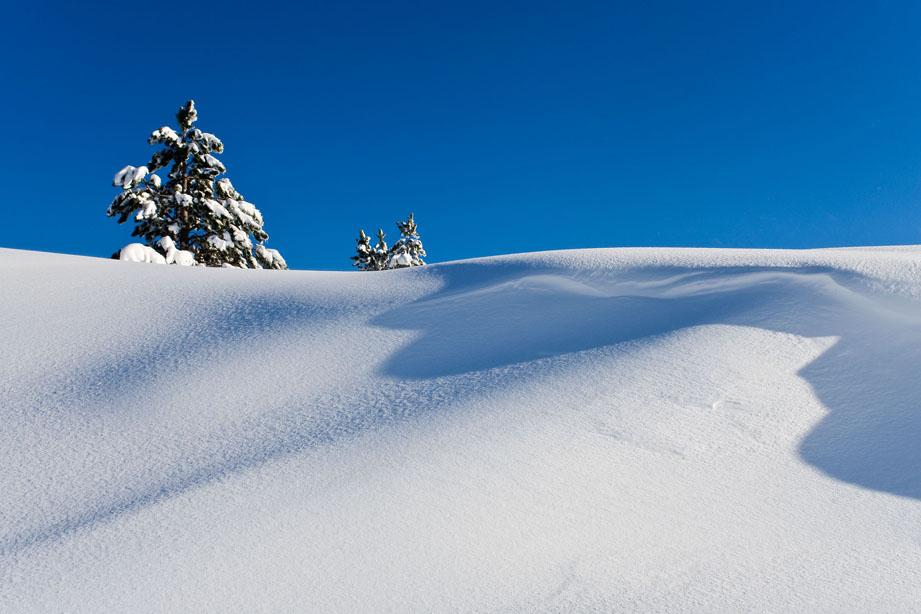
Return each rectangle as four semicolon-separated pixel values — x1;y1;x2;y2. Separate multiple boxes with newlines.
0;247;921;613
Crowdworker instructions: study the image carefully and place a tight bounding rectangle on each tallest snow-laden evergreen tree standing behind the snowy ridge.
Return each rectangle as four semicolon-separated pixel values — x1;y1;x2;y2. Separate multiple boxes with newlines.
108;100;288;269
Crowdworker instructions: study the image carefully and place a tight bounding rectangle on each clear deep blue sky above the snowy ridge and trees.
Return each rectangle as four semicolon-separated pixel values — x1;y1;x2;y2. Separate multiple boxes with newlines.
0;0;921;269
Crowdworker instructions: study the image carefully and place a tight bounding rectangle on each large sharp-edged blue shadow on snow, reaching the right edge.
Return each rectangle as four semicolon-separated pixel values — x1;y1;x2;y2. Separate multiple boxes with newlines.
373;263;921;499
